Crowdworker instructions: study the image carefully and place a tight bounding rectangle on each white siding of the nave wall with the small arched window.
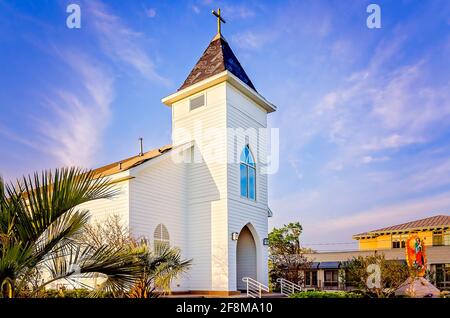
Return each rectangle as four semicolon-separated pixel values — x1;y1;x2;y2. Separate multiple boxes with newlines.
130;155;191;290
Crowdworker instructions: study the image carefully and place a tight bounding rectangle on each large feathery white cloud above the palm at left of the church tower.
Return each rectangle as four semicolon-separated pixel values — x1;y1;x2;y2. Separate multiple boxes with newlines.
33;52;114;167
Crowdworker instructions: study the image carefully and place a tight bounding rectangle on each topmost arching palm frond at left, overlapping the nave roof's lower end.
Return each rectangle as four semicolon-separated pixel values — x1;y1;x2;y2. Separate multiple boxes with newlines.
6;168;117;241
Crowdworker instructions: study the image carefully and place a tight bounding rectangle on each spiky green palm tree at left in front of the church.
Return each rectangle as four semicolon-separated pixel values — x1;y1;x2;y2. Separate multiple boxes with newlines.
0;168;145;297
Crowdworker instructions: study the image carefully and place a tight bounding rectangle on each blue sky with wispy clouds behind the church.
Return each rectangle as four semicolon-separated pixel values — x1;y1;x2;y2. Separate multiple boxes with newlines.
0;0;450;250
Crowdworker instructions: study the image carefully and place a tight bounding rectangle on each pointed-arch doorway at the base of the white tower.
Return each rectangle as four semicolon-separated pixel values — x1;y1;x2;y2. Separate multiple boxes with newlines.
236;226;257;290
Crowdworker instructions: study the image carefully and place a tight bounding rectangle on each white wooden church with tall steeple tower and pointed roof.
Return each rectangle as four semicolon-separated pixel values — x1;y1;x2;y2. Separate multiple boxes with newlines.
82;23;276;295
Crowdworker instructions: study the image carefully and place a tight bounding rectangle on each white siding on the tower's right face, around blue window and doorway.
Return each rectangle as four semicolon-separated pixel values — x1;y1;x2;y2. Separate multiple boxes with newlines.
227;84;268;290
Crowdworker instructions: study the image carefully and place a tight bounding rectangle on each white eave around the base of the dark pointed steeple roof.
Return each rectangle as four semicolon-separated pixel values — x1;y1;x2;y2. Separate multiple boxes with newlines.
161;70;277;113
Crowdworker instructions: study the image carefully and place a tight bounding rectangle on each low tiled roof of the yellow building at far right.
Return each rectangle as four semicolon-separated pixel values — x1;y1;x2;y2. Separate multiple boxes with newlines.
353;215;450;238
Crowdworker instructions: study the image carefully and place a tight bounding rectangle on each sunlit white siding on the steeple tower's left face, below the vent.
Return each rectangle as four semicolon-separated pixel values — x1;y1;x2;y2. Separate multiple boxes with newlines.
172;84;228;290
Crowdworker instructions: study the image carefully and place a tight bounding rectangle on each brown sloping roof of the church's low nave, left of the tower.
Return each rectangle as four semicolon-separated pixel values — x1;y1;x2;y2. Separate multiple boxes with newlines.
93;145;172;177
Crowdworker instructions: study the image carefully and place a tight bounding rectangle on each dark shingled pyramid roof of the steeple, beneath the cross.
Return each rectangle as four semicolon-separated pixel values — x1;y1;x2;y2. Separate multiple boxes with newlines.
178;34;256;92
